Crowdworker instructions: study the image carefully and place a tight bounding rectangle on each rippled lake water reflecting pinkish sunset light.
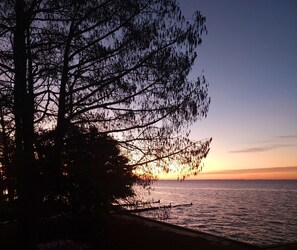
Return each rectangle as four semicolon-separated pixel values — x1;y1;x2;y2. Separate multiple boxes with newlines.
132;180;297;246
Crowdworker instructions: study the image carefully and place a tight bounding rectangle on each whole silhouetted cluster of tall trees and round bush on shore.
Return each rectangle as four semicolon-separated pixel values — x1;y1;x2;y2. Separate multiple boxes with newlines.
0;0;211;249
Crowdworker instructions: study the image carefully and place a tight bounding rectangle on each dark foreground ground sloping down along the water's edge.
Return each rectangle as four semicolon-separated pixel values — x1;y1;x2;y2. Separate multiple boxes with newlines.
0;215;297;250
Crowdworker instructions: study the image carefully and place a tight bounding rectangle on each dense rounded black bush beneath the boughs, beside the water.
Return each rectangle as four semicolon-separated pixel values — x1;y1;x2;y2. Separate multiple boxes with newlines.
62;127;139;209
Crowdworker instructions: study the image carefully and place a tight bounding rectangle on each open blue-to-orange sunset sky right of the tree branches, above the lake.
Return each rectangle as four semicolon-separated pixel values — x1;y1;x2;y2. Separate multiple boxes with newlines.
163;0;297;179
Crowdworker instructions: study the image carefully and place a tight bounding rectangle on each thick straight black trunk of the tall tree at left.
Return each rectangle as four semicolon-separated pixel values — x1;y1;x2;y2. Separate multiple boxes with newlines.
14;0;38;249
